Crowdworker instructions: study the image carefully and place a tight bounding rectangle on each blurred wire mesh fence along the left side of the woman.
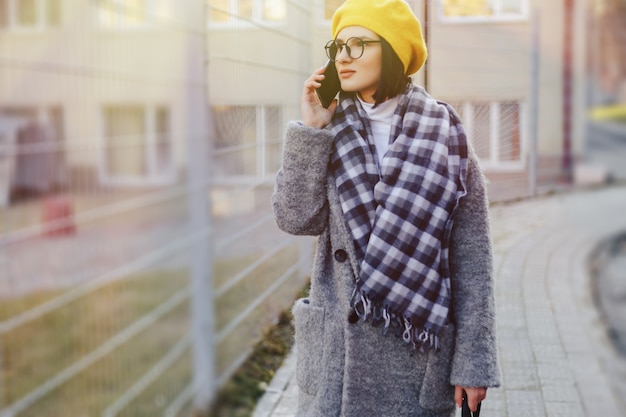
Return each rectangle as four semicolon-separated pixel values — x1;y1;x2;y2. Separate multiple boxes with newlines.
0;0;310;417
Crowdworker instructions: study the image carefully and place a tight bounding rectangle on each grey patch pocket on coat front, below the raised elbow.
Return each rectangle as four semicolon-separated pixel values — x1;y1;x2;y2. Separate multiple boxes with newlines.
293;298;324;395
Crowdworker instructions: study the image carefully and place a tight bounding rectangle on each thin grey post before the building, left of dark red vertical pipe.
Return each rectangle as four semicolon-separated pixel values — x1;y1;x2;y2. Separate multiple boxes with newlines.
528;10;540;196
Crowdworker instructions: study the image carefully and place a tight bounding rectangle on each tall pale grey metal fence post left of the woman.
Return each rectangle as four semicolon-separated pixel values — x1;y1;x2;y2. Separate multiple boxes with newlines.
184;1;216;415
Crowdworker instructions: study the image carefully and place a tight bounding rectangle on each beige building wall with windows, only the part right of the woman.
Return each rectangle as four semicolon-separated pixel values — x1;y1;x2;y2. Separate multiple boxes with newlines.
420;0;586;197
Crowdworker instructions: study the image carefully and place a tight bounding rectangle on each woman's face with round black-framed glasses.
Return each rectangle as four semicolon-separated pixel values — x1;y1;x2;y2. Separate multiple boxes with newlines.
335;26;382;103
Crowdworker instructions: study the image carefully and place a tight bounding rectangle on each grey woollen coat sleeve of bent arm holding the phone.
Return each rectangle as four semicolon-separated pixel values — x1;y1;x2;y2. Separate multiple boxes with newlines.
272;122;333;235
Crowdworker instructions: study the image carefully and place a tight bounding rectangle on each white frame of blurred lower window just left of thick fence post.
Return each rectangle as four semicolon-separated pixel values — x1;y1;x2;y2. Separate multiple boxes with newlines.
98;102;176;187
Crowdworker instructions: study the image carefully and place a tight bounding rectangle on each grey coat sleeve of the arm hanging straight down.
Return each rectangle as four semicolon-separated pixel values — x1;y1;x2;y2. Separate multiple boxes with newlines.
450;153;500;387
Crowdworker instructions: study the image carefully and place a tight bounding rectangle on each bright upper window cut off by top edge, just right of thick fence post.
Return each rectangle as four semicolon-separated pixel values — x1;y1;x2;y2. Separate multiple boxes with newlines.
208;0;287;25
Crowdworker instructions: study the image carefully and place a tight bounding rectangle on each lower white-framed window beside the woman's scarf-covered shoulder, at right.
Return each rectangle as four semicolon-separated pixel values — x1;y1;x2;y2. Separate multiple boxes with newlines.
451;101;523;167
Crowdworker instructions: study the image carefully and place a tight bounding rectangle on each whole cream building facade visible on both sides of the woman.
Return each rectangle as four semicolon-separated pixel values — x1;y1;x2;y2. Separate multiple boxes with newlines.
0;0;586;202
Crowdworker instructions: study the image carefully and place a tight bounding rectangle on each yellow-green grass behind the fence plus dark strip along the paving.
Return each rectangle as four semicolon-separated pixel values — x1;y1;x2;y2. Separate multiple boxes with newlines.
0;248;302;417
